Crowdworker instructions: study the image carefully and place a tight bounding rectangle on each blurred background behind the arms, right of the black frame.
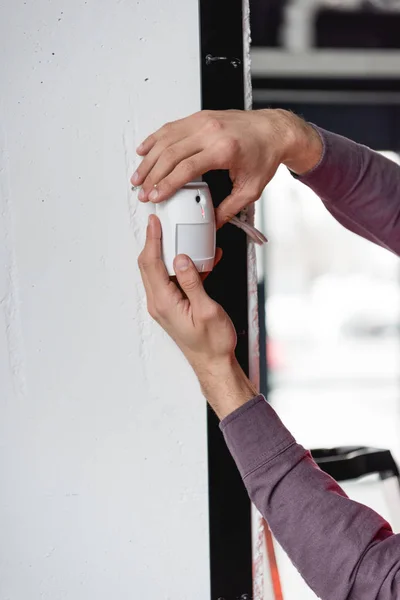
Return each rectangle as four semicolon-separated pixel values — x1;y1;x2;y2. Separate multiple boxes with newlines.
250;0;400;600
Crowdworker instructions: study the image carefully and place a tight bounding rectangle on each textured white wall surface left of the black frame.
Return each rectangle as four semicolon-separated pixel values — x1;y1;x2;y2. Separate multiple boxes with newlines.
0;0;210;600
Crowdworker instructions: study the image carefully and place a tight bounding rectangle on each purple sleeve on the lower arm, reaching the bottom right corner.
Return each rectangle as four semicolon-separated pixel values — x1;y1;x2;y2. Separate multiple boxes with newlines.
221;396;400;600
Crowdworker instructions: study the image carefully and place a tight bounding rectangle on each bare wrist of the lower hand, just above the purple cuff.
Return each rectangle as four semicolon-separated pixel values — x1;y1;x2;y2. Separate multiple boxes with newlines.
195;356;258;420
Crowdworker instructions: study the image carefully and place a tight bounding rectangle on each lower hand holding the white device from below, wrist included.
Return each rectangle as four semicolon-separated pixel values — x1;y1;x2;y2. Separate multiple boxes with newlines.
138;215;256;418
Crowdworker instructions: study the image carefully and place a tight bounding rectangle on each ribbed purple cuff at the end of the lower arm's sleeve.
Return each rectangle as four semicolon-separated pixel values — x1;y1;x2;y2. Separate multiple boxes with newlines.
220;395;295;478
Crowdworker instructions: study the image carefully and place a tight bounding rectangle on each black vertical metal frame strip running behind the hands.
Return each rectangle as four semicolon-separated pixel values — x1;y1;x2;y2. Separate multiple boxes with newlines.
199;0;252;600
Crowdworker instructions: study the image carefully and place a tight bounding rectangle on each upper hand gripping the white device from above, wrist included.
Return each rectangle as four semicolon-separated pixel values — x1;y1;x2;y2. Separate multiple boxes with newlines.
131;110;322;227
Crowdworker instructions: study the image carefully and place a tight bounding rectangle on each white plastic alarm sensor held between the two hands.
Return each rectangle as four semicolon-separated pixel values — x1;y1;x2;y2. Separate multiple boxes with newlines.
156;181;215;275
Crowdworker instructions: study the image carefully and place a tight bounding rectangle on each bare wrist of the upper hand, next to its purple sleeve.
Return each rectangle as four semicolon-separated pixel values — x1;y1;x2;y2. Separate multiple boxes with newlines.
272;109;323;175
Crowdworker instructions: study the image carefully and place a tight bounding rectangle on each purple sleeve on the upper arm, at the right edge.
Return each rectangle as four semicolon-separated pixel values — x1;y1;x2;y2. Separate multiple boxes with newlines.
296;126;400;256
